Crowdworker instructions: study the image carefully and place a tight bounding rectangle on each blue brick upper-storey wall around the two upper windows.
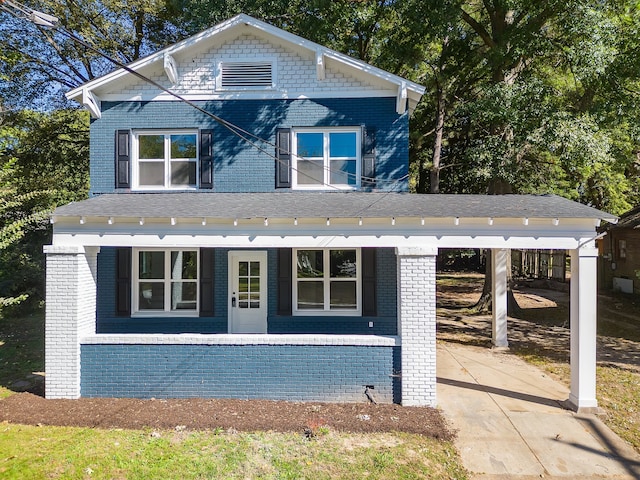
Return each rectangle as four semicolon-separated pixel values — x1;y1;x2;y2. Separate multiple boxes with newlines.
90;98;409;194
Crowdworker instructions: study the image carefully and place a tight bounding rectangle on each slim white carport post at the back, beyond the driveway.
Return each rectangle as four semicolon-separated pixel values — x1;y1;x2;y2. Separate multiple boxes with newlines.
491;248;509;348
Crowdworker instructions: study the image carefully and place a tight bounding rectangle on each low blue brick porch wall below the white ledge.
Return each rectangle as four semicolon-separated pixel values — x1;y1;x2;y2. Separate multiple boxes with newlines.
81;345;400;403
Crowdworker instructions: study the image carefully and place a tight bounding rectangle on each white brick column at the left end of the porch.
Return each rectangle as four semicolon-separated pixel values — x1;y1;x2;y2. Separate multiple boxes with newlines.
44;245;100;398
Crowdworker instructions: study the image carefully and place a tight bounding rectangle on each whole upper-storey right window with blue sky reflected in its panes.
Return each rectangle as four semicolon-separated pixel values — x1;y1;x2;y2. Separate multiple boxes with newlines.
291;127;362;190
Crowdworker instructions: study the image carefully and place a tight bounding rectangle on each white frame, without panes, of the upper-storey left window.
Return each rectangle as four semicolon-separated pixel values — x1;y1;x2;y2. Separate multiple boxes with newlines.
131;129;200;191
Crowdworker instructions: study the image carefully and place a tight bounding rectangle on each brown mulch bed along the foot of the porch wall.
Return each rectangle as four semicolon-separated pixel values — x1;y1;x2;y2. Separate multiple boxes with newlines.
0;392;453;440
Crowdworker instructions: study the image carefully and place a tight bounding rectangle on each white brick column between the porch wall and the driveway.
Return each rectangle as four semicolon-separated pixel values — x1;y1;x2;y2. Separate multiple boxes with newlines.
396;247;438;407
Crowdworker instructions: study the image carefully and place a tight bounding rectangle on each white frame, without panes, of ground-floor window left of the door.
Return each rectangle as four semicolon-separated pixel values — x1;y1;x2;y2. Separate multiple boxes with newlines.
131;247;200;317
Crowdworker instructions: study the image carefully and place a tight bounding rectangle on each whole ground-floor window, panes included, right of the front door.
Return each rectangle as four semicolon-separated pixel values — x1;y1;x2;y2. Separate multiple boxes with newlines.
293;248;362;315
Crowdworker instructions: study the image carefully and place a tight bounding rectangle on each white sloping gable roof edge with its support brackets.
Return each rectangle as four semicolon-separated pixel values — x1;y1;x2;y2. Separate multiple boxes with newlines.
66;14;425;116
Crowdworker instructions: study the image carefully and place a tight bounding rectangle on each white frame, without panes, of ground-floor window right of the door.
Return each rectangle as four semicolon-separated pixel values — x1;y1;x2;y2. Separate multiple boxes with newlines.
291;248;362;317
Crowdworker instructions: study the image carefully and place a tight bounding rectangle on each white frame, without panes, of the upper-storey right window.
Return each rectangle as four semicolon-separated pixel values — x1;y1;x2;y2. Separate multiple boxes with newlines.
291;126;362;190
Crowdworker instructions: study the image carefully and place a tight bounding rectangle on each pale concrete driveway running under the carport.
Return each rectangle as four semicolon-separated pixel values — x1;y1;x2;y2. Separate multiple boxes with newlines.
437;342;640;480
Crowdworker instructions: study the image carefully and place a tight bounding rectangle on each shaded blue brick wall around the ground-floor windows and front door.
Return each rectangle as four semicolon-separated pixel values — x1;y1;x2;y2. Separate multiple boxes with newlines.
96;247;397;335
